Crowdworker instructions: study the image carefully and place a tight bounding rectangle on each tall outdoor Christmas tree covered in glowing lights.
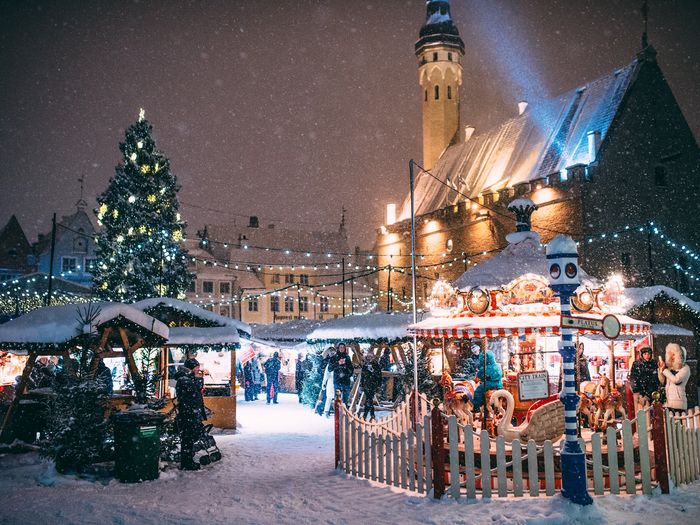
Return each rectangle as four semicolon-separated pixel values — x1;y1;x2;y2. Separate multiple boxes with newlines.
93;109;192;302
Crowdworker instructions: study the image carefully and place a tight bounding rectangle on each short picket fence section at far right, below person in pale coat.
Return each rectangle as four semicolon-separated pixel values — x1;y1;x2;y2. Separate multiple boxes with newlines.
666;407;700;485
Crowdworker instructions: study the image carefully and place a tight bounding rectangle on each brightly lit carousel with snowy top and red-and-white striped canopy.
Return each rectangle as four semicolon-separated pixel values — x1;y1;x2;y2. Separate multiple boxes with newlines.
410;232;651;421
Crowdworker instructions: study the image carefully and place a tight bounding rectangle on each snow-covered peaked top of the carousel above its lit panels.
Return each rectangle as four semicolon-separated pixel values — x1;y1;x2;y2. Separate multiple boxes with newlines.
455;232;598;290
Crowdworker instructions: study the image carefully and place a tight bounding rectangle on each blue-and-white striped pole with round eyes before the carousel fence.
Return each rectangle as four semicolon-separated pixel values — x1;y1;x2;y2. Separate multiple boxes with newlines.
547;235;593;505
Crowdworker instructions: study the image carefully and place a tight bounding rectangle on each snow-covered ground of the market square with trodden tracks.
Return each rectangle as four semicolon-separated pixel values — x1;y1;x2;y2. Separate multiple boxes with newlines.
0;395;700;525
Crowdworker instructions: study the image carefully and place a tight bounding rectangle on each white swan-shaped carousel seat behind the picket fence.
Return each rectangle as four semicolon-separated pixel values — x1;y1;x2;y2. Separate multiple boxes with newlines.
490;390;564;445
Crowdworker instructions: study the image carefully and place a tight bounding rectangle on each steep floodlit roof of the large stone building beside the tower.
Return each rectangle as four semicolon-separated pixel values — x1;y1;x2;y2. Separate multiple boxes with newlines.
399;57;645;220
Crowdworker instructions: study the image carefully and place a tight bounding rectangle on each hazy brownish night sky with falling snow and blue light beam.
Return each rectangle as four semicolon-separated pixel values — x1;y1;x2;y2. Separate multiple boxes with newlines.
0;0;700;247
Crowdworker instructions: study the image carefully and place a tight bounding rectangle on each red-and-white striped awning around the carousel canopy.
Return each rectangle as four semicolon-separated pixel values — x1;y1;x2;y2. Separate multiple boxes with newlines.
408;315;651;339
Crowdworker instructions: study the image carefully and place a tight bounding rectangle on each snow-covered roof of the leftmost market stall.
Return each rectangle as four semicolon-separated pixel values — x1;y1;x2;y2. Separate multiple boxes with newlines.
0;302;169;349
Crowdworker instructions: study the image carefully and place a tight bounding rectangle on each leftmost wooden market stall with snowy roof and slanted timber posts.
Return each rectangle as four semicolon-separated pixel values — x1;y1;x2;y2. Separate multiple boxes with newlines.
0;302;169;441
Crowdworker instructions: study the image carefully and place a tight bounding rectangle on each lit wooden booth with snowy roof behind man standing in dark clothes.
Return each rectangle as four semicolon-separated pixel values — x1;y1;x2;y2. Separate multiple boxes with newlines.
133;297;251;429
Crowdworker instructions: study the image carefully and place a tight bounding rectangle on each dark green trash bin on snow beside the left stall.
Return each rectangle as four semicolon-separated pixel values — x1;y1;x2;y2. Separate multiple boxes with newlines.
112;410;165;483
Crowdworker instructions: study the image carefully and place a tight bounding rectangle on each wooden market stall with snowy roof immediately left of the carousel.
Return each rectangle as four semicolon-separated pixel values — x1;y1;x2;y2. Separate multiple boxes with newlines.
307;312;413;412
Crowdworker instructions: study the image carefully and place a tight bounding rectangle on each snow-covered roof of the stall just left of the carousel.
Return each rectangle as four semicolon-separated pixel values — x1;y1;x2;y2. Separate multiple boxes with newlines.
306;312;413;342
